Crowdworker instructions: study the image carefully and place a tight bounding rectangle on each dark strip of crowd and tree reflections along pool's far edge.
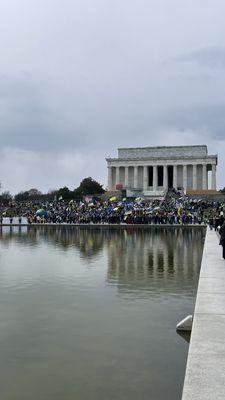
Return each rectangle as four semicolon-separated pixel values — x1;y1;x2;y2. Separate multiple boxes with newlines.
0;225;204;253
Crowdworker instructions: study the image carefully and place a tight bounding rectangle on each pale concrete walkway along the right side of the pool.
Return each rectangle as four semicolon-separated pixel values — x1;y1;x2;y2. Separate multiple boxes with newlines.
182;228;225;400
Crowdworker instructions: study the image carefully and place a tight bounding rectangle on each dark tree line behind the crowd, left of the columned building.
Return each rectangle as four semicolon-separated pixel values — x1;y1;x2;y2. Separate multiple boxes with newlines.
0;177;105;204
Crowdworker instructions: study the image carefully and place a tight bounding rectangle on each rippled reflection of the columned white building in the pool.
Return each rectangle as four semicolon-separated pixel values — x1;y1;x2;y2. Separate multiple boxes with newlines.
108;228;204;291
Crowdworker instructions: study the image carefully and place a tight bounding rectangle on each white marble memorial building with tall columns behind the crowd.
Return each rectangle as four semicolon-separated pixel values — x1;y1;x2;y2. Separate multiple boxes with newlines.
106;145;217;196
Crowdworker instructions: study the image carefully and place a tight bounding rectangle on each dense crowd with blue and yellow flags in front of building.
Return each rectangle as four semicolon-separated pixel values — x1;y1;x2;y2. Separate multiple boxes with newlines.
0;192;225;228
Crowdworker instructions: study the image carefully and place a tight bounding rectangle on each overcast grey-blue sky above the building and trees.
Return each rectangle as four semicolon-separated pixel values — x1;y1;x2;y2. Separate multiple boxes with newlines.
0;0;225;193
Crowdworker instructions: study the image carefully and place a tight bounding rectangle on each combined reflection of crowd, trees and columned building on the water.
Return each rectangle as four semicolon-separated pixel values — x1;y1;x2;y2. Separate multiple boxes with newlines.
0;226;204;291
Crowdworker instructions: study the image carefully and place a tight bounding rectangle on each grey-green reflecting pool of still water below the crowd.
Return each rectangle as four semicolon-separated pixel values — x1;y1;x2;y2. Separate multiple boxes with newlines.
0;226;204;400
